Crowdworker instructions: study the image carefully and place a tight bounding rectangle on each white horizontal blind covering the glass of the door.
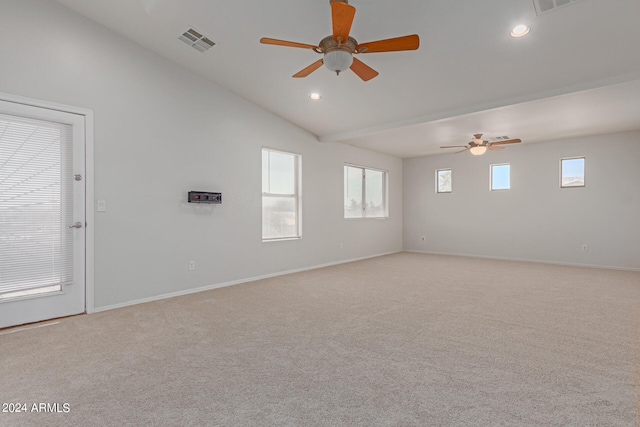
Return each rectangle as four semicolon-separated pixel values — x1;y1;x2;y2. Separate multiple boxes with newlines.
0;114;73;299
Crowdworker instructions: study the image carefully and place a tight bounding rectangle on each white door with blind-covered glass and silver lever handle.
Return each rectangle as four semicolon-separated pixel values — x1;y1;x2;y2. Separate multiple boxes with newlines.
0;101;86;328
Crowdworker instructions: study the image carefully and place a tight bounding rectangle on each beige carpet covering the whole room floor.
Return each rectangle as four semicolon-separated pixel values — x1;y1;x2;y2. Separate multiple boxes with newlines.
0;253;640;426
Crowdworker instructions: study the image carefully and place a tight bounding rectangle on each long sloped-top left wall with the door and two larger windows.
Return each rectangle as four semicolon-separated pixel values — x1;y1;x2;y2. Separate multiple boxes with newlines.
0;0;402;309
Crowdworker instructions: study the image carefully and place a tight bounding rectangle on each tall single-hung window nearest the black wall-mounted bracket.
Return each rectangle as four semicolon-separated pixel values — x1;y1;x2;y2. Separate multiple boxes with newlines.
262;148;301;241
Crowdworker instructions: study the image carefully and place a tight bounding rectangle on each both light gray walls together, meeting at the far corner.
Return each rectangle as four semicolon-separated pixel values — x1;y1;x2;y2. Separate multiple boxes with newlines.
0;0;640;318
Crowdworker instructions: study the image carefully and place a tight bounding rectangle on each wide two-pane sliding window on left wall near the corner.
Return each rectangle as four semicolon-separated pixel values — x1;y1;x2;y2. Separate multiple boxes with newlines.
344;165;387;218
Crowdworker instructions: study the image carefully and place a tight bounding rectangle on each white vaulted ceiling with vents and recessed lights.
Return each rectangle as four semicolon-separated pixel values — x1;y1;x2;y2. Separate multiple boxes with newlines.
58;0;640;157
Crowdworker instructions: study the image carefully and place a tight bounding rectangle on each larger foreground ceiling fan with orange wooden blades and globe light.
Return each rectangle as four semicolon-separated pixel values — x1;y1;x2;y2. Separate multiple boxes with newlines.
260;0;420;81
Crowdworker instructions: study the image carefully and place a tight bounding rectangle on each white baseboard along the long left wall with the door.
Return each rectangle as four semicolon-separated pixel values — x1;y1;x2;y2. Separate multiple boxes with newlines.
87;251;402;314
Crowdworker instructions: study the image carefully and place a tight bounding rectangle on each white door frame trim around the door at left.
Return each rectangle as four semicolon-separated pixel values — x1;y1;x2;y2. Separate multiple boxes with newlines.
0;92;95;313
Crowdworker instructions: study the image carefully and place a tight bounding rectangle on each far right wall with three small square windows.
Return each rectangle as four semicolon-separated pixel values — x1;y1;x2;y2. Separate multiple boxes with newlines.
404;132;640;269
